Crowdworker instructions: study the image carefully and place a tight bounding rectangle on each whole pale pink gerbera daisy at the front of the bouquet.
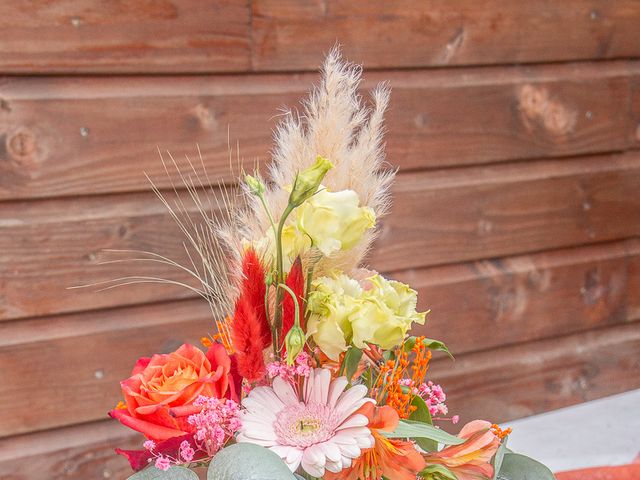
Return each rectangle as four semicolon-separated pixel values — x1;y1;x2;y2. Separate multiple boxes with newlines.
238;368;374;477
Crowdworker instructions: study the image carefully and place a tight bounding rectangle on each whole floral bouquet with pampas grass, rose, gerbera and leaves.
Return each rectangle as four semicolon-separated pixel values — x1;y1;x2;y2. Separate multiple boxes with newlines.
110;50;553;480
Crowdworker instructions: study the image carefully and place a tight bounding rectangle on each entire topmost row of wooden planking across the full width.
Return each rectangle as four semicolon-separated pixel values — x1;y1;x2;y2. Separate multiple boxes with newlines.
5;0;640;73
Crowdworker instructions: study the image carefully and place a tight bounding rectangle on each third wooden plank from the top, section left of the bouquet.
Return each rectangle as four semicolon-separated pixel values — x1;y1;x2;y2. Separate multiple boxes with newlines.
0;189;200;319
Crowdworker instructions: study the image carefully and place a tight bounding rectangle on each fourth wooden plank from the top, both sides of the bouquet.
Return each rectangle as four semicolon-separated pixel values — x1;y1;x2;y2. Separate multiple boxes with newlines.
0;241;640;436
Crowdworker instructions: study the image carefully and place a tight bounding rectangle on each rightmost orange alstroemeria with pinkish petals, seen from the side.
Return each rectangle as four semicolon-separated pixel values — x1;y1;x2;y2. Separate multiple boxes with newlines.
425;420;500;480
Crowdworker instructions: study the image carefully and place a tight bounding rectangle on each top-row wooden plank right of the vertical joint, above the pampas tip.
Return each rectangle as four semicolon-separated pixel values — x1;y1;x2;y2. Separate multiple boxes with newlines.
253;0;640;70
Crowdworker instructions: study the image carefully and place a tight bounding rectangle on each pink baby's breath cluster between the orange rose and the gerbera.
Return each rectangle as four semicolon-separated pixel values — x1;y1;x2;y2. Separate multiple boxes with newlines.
189;396;242;460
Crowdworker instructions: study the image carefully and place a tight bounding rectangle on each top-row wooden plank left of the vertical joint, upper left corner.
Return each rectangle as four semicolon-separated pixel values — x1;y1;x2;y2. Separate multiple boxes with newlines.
0;0;250;73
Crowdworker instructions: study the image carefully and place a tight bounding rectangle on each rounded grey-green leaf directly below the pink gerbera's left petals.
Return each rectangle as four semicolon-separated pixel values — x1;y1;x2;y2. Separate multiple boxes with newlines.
207;443;296;480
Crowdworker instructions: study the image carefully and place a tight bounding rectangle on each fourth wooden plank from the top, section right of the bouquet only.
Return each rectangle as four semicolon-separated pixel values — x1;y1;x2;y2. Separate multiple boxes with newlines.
402;241;640;355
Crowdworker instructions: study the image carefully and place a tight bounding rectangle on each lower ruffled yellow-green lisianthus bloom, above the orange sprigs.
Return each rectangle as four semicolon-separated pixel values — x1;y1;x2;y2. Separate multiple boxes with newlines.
307;272;426;360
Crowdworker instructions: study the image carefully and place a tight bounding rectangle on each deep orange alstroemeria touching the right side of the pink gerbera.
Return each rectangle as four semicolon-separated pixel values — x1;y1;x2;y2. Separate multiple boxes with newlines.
324;403;425;480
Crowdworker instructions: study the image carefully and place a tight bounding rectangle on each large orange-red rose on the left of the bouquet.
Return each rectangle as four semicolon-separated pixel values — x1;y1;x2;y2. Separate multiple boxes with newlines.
109;344;241;441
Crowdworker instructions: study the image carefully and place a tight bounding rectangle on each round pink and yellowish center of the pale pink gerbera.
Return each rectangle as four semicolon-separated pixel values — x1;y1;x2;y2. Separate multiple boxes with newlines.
273;403;339;447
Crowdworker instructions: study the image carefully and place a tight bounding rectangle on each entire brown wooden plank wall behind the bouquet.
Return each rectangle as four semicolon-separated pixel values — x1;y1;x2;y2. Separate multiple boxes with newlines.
0;0;640;480
